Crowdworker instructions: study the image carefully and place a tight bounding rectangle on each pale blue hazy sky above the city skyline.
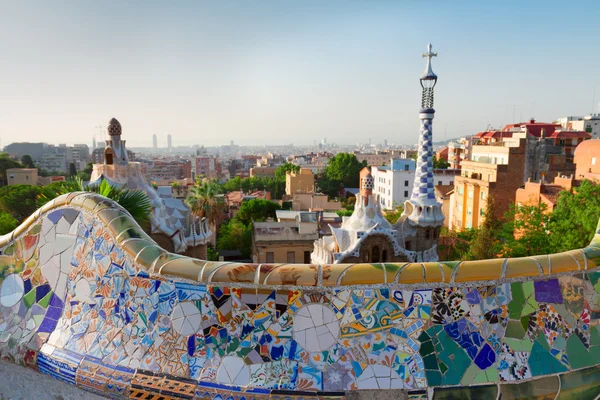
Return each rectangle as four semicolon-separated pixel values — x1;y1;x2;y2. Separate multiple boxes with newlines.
0;0;600;146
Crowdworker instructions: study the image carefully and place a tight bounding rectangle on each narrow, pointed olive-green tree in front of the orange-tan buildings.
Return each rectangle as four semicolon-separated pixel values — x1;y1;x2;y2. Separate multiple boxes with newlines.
469;196;502;260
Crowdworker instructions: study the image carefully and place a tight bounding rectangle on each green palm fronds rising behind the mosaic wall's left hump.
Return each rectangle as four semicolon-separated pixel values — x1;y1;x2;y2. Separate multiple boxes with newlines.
37;178;152;228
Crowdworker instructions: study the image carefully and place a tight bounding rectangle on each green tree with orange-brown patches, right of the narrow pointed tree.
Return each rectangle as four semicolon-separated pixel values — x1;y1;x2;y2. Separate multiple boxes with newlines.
501;203;552;257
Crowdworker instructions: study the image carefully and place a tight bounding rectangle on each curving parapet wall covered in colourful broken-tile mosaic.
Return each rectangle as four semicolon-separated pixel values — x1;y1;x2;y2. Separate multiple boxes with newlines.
0;193;600;399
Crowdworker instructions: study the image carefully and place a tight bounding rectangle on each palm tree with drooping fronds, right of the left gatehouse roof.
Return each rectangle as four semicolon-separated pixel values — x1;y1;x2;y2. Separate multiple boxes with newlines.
185;181;225;226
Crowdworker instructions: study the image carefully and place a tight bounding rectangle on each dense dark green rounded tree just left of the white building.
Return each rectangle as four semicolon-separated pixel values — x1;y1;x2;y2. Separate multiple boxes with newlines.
317;153;367;197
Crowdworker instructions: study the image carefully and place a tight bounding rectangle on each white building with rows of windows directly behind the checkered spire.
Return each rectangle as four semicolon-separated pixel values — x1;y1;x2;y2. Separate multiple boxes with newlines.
371;158;460;210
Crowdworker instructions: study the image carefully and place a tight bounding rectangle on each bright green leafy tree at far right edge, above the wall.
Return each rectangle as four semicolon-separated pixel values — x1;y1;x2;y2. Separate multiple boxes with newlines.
548;180;600;252
